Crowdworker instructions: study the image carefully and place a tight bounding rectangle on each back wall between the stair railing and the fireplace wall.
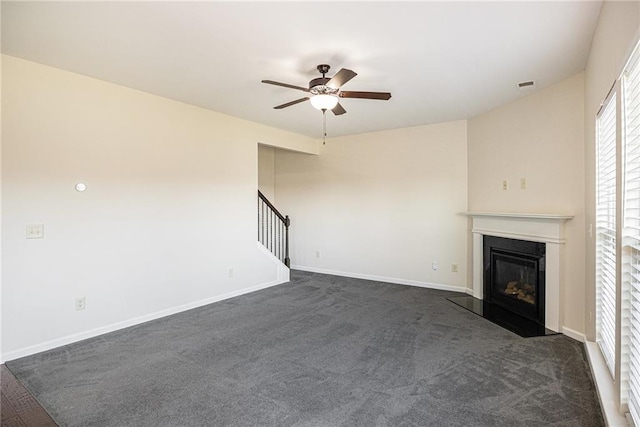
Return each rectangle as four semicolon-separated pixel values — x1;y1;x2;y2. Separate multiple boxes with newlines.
276;121;467;290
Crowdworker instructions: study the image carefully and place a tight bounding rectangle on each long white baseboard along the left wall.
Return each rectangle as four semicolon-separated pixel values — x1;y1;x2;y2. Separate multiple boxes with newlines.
1;278;289;363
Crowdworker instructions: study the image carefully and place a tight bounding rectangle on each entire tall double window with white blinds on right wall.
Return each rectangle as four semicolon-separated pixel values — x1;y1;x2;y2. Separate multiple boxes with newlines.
595;35;640;426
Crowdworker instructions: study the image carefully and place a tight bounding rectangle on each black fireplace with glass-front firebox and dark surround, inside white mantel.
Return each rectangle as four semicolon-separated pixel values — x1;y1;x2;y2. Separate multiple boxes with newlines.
483;236;546;325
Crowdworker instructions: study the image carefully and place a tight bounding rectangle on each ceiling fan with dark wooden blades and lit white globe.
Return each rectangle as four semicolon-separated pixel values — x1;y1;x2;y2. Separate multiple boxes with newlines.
262;64;391;116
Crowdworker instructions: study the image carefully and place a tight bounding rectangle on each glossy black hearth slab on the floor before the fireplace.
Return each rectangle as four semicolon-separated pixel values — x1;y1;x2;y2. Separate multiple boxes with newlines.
447;295;558;338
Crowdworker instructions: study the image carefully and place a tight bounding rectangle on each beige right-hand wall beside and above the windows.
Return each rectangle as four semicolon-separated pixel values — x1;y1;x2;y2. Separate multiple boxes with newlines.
584;1;640;341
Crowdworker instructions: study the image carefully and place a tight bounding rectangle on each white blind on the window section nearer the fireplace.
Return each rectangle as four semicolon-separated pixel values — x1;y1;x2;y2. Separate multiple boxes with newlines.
596;92;616;376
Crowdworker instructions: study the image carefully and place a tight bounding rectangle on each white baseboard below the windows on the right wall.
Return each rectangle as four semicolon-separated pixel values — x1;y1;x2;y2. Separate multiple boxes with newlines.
584;340;629;427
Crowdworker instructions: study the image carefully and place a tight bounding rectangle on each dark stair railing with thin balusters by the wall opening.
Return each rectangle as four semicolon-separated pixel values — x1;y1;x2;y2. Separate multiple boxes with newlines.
258;190;291;267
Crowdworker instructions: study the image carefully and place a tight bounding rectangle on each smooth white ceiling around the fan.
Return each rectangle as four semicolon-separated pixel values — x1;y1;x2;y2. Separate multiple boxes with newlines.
2;1;601;137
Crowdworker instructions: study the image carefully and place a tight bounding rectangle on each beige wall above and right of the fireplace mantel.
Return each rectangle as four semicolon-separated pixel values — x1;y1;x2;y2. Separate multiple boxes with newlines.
468;74;585;333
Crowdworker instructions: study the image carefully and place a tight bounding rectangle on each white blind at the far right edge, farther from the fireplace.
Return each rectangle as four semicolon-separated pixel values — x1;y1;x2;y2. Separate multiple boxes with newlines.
622;41;640;425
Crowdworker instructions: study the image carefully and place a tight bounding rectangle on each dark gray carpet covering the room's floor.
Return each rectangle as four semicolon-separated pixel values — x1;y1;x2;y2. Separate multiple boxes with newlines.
7;271;604;426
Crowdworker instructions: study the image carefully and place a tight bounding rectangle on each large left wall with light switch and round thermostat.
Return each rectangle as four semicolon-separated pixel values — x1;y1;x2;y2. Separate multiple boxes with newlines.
2;56;317;360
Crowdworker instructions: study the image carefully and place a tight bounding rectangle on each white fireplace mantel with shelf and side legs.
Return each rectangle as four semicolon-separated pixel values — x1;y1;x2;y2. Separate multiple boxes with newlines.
462;212;573;332
